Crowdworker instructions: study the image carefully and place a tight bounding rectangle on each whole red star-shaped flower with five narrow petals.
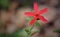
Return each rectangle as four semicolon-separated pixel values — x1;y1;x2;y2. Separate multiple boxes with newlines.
25;3;48;25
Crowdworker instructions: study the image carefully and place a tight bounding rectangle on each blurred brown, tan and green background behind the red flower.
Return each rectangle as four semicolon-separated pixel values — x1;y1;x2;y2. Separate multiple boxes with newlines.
0;0;60;37
